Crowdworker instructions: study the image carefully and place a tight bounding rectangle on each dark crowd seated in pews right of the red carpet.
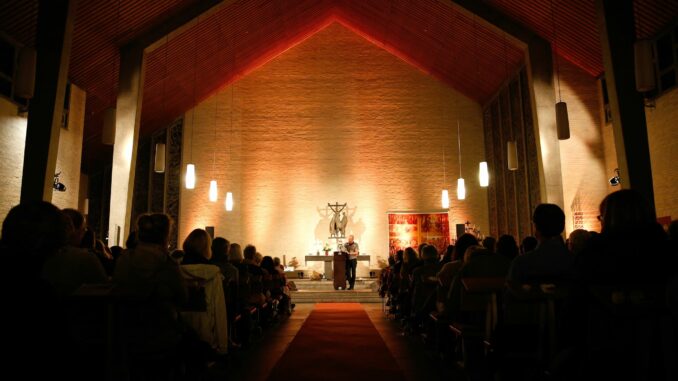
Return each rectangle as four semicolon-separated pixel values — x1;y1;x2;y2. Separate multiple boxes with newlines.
380;190;678;380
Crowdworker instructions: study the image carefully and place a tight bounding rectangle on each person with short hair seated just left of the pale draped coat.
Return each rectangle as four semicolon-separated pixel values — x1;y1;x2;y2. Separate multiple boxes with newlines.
113;213;187;379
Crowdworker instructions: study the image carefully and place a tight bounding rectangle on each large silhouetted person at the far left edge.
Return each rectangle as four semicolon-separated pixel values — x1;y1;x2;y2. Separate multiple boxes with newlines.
0;201;82;380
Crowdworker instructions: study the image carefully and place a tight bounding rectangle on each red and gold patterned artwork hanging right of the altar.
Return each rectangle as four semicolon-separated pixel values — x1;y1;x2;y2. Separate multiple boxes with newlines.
388;212;450;255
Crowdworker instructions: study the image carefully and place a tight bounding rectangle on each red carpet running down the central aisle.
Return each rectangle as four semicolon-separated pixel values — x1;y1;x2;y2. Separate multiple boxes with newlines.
269;303;405;381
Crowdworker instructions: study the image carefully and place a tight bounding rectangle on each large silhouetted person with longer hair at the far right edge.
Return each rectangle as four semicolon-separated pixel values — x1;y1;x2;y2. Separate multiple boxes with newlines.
572;189;678;380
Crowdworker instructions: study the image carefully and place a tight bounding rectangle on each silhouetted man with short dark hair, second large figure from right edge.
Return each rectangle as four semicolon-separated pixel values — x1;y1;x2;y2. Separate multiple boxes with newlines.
508;204;574;284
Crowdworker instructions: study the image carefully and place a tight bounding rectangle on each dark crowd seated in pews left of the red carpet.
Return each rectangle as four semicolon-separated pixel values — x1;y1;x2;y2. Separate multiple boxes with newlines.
0;202;294;380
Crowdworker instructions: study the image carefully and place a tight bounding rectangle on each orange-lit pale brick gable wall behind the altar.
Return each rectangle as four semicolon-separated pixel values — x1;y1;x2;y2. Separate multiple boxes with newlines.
179;24;488;274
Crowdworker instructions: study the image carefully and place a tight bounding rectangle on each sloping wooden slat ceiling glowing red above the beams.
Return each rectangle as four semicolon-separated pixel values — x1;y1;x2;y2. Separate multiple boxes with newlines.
0;0;678;169
